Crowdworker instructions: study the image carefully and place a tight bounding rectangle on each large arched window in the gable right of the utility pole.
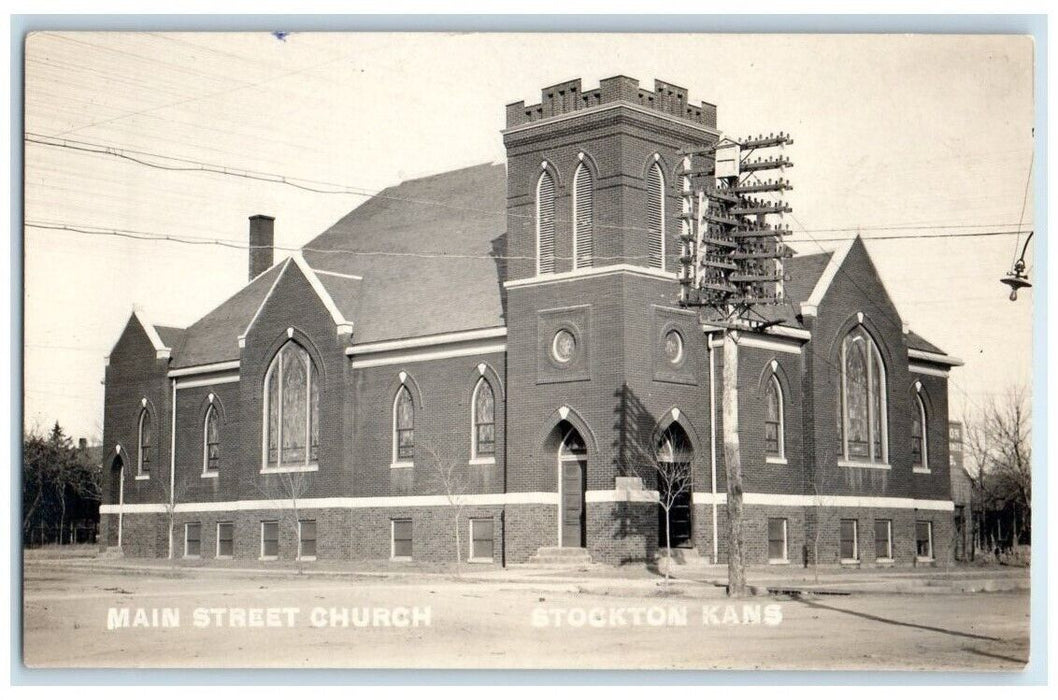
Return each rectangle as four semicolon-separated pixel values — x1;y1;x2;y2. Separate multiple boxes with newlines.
841;327;889;464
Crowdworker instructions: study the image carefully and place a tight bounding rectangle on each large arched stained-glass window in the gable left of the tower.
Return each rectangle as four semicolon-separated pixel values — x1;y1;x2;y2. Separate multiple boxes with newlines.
265;340;320;469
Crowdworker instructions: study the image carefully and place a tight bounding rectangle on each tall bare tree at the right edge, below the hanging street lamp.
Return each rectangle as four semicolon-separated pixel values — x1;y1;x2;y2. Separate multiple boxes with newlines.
966;386;1033;547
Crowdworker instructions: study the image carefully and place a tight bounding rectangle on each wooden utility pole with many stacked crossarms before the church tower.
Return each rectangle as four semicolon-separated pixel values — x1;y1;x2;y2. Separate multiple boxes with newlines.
679;132;794;596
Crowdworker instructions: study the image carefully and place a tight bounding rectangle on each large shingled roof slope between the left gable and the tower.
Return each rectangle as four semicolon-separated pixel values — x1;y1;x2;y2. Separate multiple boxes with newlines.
303;165;507;343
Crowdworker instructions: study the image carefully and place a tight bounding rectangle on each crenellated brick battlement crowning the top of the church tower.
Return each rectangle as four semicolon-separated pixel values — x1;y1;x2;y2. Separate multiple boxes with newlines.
507;75;716;129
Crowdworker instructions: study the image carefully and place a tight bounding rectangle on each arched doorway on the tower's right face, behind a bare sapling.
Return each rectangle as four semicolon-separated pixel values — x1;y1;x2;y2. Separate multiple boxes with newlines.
656;423;694;548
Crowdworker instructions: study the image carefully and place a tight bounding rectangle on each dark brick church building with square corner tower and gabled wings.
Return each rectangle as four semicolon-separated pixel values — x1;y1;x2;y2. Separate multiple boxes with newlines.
101;76;961;566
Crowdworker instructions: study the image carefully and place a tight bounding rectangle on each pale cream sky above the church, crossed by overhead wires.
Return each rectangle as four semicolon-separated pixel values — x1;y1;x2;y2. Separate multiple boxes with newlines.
25;33;1042;439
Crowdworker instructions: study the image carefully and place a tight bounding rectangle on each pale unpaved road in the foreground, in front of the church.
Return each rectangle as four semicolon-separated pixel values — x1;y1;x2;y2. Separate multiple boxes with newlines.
23;563;1028;670
